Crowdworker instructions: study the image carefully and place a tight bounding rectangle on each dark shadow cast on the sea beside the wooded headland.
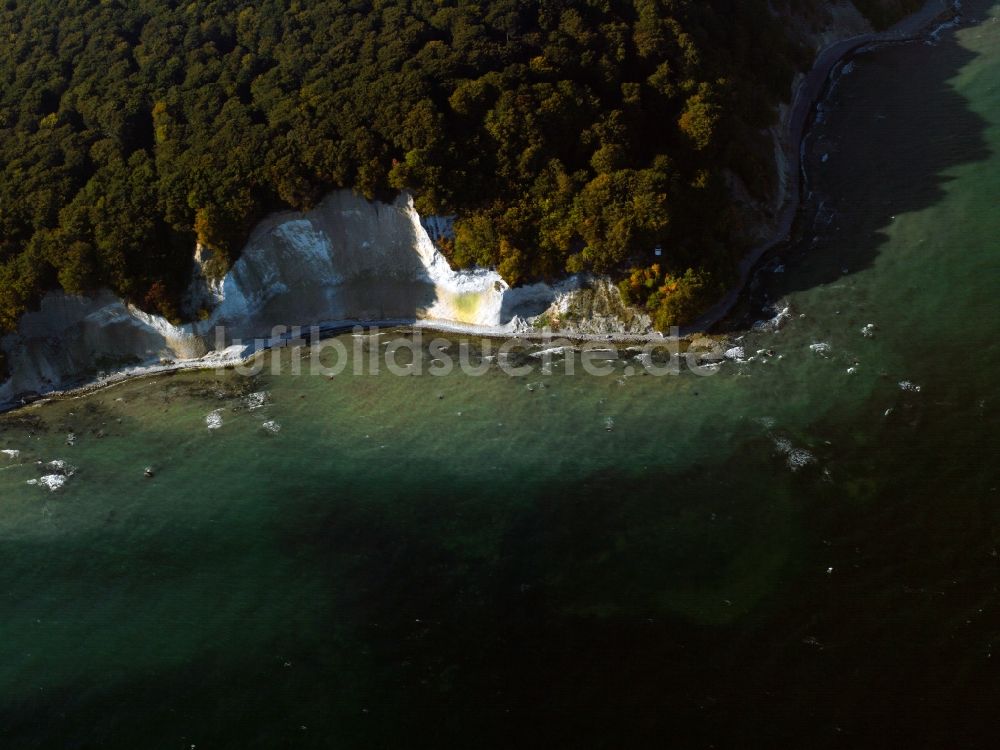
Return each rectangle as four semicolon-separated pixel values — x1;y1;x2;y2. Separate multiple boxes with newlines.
719;19;991;332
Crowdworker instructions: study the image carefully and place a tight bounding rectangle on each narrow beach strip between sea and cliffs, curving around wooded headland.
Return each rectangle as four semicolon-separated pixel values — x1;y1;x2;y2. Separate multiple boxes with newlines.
0;0;960;414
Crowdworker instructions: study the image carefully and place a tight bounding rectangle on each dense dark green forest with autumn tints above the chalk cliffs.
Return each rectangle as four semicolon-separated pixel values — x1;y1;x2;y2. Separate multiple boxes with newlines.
0;0;916;338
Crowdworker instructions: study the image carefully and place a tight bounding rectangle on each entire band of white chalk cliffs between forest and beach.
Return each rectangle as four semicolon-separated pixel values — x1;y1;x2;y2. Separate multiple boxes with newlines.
0;190;649;404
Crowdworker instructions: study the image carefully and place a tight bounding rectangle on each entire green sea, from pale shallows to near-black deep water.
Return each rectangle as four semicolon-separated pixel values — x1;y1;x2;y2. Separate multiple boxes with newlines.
0;4;1000;750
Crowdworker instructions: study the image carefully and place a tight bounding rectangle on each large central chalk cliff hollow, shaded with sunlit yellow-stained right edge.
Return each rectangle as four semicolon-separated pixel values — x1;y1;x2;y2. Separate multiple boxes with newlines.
211;191;509;335
